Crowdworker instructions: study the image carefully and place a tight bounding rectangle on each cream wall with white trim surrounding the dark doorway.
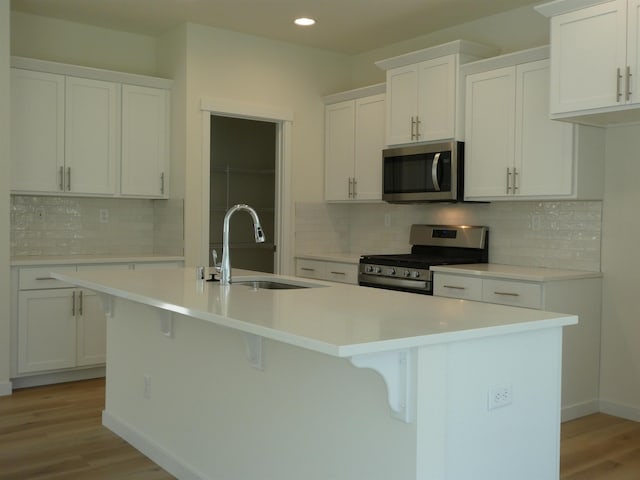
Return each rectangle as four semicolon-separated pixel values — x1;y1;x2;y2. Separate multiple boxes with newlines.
176;24;350;265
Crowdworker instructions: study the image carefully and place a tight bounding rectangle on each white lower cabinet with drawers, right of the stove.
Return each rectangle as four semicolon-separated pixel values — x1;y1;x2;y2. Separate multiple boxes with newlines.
433;266;602;421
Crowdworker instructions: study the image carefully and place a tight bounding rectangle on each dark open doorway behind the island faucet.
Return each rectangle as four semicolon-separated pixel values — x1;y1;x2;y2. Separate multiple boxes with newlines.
209;115;279;273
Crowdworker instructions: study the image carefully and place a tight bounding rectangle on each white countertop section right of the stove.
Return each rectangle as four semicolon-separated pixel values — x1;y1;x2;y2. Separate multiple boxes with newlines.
430;263;602;282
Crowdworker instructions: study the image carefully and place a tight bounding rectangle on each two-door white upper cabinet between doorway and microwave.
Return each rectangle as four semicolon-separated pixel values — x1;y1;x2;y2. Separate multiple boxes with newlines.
325;85;385;201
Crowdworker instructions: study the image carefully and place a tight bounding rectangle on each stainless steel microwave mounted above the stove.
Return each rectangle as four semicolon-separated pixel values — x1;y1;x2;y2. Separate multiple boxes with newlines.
382;141;464;203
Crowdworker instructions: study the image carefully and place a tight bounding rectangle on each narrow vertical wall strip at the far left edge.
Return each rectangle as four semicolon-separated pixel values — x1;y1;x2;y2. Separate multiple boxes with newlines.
0;0;11;395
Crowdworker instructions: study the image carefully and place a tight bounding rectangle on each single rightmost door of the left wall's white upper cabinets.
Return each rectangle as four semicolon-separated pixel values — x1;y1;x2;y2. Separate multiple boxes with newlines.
121;85;169;197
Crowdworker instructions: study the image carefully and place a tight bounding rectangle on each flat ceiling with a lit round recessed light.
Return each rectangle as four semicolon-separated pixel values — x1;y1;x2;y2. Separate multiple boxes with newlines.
11;0;539;54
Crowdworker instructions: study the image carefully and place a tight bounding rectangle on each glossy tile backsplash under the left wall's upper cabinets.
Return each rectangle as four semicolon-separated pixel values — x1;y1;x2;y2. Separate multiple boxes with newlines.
11;195;184;257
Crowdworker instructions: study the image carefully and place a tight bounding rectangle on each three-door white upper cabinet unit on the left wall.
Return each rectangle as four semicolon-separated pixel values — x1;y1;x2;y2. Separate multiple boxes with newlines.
11;57;171;198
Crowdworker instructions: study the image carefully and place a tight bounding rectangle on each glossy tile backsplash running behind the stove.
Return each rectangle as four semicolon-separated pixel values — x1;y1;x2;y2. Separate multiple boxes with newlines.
295;201;602;271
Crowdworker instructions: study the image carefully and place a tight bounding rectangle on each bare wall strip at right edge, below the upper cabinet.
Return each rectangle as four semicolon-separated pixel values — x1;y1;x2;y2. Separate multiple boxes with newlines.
600;126;640;421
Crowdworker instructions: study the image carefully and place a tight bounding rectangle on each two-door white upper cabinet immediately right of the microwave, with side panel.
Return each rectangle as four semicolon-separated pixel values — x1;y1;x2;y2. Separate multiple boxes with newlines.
462;47;604;200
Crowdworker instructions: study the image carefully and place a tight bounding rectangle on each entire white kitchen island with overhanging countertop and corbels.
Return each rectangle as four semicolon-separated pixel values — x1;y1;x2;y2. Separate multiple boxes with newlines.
52;268;577;480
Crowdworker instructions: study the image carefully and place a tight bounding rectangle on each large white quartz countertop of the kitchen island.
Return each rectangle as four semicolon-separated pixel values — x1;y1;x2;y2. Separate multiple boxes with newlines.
52;268;578;357
